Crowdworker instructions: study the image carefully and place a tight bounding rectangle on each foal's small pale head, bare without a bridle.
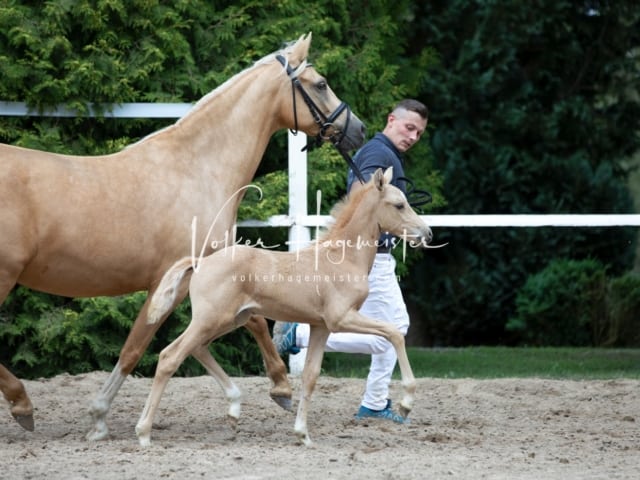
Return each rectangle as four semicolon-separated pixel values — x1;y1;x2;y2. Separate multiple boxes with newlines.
371;167;433;247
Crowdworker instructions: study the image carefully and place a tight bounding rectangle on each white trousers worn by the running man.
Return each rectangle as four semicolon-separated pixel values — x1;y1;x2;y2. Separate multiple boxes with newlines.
296;253;409;410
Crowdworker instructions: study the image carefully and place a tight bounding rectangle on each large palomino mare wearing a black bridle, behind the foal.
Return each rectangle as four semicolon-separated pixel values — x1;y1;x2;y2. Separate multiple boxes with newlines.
0;34;364;439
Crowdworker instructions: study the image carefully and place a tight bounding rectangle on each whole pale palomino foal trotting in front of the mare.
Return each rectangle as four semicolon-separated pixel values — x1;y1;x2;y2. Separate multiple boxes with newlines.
136;168;432;446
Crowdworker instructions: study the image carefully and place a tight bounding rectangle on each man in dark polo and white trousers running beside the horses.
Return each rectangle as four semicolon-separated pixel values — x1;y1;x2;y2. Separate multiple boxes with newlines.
273;99;429;423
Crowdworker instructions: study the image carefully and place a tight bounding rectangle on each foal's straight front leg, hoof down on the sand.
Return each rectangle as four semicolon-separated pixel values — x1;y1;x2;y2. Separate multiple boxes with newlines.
293;325;329;446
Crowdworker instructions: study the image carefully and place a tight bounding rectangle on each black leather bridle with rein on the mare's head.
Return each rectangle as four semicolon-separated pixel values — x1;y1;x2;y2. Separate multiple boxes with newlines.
276;55;365;183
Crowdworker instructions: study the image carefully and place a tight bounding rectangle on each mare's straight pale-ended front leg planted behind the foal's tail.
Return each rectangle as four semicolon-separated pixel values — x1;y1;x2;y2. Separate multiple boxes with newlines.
86;282;188;440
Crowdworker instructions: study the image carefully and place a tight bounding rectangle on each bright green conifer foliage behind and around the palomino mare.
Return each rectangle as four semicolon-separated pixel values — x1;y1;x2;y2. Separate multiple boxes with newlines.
0;0;441;377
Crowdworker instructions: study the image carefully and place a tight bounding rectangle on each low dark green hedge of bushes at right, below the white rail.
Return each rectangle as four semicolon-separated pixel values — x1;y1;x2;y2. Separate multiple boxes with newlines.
506;259;640;347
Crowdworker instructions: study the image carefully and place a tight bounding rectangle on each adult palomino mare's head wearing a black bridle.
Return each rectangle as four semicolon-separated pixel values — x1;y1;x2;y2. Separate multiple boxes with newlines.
275;33;366;155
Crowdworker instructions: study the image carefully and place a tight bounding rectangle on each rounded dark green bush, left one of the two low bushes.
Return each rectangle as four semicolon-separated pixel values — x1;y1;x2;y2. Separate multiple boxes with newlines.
506;259;607;346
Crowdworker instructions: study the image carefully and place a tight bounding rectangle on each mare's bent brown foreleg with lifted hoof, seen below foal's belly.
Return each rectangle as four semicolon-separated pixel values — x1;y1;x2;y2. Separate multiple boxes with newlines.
245;315;292;410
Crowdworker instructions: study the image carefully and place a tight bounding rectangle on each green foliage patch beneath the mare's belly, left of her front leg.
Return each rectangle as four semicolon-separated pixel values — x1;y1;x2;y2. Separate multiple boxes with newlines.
0;287;139;378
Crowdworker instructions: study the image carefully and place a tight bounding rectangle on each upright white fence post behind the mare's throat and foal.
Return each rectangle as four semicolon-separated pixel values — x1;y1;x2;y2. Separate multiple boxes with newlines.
288;131;311;376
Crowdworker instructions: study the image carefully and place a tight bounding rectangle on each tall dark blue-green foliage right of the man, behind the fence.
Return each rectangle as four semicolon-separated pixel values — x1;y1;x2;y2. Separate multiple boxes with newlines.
408;0;640;345
